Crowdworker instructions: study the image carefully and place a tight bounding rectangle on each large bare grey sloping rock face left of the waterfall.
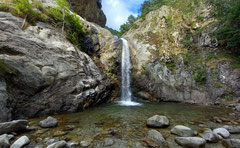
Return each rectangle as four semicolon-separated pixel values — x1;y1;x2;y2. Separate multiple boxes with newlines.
0;12;112;120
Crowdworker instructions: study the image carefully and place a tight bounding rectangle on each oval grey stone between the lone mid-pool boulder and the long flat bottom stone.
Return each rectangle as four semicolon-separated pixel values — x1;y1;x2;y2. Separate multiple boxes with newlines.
171;125;196;137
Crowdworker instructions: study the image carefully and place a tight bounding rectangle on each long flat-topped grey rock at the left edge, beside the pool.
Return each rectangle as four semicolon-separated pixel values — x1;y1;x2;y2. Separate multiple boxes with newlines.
0;120;28;134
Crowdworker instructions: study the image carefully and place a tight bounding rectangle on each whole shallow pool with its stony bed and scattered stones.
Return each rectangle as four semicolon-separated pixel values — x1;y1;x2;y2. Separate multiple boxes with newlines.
0;103;240;148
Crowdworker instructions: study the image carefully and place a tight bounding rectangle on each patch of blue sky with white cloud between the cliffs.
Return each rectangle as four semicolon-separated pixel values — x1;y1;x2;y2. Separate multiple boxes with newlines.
102;0;144;30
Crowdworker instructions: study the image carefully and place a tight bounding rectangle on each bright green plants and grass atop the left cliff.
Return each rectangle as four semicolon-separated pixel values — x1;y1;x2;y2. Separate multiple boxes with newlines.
0;0;86;49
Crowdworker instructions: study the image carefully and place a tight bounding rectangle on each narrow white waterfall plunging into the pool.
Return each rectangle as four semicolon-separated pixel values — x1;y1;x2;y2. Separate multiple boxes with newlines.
120;38;140;106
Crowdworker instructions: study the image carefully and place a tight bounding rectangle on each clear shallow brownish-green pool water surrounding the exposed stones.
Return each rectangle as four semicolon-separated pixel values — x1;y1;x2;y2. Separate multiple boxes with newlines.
22;103;240;148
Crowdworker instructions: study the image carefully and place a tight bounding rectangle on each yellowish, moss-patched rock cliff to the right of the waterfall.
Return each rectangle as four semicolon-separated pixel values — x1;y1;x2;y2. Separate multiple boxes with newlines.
124;4;240;104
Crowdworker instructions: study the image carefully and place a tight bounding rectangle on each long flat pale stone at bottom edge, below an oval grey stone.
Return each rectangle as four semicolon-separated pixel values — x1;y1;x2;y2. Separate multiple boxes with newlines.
175;137;206;148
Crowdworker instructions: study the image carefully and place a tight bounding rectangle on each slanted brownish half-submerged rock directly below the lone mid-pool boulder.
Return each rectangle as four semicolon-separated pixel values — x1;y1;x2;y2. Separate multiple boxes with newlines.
148;130;167;147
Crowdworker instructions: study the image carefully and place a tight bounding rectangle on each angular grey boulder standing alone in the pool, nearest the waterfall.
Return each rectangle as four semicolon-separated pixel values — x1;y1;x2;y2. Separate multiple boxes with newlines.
147;115;169;127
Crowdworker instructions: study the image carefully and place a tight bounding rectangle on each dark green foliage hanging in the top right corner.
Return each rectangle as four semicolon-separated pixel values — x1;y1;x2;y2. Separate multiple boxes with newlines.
207;0;240;52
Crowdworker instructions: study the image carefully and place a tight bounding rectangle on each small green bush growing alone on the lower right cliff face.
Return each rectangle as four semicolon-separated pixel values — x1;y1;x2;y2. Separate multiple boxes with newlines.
194;66;207;84
